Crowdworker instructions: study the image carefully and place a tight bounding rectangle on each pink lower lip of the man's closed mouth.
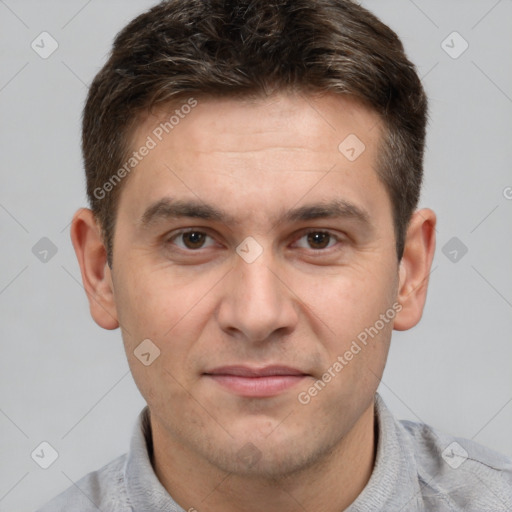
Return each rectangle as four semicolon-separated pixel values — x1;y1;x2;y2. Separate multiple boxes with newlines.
207;375;306;398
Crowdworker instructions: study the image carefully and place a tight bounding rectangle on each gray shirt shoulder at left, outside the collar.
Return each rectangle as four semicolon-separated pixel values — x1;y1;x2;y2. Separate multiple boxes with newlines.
37;454;132;512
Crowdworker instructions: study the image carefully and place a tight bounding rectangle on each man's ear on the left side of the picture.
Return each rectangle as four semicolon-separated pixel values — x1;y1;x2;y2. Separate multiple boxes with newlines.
71;208;119;329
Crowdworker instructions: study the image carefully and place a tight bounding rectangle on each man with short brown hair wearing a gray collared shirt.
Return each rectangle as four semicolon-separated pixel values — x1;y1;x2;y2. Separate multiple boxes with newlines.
37;0;512;512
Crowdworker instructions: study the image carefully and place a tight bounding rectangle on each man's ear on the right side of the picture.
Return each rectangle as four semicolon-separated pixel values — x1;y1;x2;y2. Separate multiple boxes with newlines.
393;208;436;331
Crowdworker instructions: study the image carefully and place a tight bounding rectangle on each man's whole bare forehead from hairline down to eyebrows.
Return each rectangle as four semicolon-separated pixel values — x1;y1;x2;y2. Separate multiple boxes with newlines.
120;93;387;228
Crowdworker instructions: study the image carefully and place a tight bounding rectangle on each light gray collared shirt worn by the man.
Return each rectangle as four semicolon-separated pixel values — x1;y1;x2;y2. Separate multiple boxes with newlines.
38;395;512;512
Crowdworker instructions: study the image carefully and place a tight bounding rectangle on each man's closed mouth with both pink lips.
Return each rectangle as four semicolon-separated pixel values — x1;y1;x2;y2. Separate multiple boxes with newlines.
203;366;309;398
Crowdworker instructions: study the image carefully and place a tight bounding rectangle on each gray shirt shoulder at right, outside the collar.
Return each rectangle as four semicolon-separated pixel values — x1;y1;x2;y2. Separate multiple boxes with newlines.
400;421;512;512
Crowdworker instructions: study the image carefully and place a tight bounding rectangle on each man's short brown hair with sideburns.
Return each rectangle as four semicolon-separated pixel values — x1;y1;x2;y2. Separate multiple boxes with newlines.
82;0;427;264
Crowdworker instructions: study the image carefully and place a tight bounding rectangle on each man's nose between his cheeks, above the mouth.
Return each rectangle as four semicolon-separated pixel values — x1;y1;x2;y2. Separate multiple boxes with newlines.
217;251;298;343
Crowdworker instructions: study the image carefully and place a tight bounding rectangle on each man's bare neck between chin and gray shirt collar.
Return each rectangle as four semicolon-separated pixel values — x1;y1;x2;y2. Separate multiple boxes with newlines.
151;402;376;512
